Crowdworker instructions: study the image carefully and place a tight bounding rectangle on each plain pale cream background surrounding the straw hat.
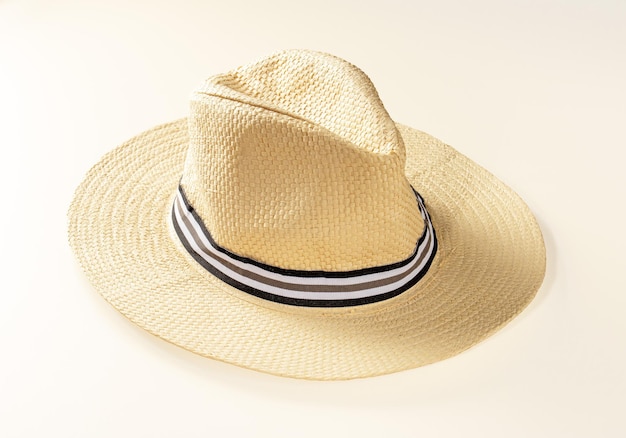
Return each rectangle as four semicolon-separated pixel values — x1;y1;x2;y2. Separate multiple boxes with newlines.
0;0;626;437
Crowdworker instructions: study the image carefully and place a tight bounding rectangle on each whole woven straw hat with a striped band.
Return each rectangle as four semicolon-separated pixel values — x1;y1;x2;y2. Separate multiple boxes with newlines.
69;50;545;380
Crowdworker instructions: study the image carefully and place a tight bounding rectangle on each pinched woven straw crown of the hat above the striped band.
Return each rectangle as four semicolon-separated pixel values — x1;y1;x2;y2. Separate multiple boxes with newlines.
181;51;424;271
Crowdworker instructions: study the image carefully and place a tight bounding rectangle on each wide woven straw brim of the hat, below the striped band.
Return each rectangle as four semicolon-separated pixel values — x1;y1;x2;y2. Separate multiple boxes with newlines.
68;119;545;380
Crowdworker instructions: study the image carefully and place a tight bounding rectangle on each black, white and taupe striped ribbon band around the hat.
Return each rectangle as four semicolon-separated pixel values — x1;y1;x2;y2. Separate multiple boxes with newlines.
172;186;437;307
